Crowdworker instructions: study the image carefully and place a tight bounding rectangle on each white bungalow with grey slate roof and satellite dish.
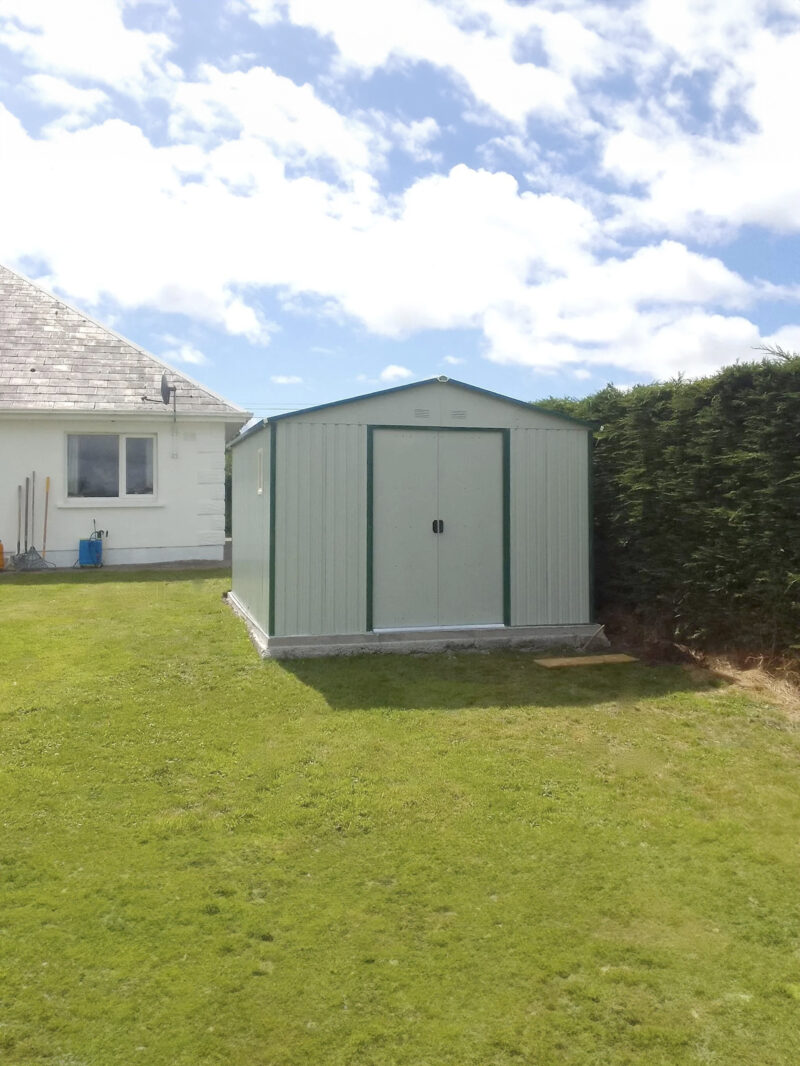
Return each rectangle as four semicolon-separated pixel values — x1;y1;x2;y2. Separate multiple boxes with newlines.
0;267;249;566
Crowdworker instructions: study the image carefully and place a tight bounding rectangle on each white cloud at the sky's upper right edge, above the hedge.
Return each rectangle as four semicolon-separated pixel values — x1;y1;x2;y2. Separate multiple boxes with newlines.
603;17;800;238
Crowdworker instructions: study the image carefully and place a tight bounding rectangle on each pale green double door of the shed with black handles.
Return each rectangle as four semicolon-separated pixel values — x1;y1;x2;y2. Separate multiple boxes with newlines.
372;429;503;629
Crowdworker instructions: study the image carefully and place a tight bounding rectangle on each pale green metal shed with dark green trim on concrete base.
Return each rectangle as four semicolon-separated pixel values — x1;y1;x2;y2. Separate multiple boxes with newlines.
229;377;599;657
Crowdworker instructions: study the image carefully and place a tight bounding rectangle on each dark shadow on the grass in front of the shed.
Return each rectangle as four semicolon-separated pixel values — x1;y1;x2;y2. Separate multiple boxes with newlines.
279;651;722;710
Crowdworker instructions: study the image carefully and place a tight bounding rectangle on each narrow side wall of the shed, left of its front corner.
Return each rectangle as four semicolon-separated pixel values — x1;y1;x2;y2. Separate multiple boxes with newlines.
231;430;270;632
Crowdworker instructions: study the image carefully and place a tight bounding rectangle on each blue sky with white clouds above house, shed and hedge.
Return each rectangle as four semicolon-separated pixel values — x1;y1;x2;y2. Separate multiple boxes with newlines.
0;0;800;416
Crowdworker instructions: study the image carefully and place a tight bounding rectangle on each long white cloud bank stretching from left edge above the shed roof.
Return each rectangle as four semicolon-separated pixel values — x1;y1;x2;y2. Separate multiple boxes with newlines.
0;99;776;382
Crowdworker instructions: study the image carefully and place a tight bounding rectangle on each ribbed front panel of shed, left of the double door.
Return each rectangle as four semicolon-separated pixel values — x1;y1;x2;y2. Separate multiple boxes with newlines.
275;420;367;636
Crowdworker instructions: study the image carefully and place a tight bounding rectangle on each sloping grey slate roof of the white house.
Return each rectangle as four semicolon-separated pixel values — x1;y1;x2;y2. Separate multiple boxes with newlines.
0;265;250;424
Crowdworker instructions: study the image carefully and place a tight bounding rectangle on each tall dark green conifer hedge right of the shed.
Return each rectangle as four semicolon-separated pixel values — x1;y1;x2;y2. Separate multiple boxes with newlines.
550;352;800;652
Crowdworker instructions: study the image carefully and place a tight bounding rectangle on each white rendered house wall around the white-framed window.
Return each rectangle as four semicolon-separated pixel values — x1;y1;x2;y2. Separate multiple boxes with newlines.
0;415;231;566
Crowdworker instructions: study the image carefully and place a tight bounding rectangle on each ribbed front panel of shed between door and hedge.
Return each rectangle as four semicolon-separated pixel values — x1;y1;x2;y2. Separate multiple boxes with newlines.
511;430;591;626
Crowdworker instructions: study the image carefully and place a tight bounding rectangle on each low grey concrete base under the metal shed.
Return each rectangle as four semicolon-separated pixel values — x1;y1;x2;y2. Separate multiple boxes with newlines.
227;592;608;659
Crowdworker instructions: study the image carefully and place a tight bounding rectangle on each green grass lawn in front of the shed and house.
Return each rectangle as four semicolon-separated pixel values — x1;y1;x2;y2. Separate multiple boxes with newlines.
0;571;800;1066
